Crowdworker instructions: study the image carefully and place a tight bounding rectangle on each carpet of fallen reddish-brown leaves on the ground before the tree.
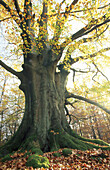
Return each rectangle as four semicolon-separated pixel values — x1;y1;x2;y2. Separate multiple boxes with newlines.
0;149;110;170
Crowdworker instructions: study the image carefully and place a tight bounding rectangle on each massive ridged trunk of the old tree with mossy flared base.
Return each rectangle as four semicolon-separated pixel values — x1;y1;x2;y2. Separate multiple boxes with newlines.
1;53;109;158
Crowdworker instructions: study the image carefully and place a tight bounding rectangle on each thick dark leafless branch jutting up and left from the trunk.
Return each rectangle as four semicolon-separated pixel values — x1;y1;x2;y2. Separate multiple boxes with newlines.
0;60;21;79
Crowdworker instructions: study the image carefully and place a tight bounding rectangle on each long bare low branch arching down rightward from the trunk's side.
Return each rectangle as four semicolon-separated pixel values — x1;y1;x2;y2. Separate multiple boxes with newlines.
66;92;110;114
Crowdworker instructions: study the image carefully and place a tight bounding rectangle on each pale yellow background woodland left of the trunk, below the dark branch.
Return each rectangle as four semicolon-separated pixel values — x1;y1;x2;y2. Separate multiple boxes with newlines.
0;69;24;144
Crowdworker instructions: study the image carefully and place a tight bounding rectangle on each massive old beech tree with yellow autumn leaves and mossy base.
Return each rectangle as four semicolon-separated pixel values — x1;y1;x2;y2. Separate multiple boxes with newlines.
0;0;110;157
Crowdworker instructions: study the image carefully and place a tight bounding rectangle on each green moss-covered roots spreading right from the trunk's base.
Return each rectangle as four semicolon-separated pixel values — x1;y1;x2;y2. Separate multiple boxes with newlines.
50;132;110;151
